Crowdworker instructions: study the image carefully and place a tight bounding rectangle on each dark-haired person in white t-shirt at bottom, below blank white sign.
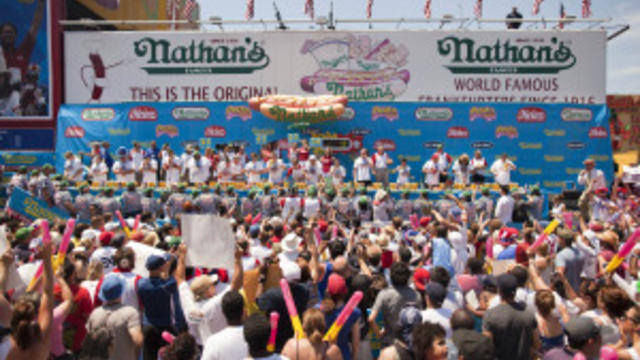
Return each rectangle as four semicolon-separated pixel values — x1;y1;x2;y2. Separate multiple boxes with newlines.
201;291;249;360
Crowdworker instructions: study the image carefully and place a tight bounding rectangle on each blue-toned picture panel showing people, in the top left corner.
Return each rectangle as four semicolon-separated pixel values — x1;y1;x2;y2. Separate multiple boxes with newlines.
0;0;52;122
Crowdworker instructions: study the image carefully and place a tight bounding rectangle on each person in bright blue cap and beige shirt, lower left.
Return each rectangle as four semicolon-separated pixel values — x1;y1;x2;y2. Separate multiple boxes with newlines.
87;274;143;360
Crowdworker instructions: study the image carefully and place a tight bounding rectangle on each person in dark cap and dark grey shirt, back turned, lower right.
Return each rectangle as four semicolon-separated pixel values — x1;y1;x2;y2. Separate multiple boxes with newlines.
482;273;540;360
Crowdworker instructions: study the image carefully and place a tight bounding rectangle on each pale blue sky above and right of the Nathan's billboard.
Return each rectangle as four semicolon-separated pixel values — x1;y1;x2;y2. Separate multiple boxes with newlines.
199;0;640;94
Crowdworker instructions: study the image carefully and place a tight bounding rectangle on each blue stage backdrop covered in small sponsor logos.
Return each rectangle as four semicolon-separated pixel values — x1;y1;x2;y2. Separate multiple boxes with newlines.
56;102;613;188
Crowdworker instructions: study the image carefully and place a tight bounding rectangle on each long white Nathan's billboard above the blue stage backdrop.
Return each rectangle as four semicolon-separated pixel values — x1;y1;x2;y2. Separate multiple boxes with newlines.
65;30;606;104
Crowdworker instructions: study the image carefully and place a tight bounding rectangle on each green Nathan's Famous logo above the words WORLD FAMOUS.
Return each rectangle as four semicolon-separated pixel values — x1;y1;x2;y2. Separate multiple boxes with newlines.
438;35;576;74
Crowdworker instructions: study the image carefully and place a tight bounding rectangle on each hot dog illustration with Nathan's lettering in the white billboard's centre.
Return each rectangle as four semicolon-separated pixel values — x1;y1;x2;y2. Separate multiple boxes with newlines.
300;34;411;101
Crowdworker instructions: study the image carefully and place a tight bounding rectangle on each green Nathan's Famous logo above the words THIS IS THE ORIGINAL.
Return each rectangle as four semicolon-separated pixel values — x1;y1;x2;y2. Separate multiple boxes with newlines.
133;37;269;75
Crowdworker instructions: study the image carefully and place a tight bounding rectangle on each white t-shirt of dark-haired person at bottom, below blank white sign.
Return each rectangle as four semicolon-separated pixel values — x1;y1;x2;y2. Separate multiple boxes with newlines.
201;326;249;360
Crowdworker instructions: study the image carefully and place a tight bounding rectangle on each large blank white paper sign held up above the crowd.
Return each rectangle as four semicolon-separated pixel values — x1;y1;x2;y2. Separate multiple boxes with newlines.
181;215;236;270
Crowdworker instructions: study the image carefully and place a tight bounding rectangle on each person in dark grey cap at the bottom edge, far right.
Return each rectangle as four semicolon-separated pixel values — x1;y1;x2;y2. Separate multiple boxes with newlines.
544;316;602;360
